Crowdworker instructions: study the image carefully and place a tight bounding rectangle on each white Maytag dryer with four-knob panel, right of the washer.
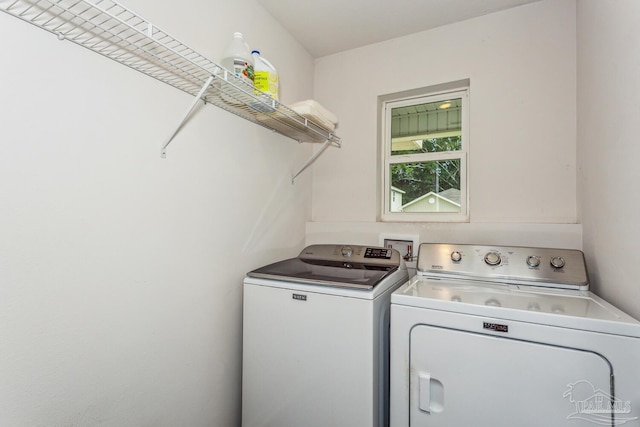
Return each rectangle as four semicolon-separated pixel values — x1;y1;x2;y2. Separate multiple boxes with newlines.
391;244;640;427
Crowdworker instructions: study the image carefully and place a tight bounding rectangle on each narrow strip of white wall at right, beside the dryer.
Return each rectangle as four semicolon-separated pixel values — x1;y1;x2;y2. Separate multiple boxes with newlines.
577;0;640;318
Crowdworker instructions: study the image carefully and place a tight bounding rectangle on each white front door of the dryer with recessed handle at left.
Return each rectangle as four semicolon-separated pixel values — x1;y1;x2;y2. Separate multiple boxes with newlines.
409;325;613;427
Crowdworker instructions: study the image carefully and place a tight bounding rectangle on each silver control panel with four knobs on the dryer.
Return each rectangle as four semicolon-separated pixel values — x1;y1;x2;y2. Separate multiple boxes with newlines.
418;243;589;290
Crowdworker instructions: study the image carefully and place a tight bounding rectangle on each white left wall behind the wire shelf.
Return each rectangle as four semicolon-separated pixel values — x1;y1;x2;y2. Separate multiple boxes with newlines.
0;0;314;427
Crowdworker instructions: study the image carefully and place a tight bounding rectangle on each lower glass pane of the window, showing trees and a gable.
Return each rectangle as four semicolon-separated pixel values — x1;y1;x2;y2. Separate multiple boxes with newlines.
389;159;460;213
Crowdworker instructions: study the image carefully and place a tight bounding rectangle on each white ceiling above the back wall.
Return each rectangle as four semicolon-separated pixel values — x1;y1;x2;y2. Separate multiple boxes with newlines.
257;0;540;58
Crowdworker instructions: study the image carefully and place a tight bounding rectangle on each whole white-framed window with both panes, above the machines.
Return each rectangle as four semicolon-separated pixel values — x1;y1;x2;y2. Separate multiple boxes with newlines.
380;86;469;222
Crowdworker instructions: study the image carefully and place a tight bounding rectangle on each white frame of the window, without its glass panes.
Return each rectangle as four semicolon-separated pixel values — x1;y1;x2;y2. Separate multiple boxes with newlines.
379;85;469;222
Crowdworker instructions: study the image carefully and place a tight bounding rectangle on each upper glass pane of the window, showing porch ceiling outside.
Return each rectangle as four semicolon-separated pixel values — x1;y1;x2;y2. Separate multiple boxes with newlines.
391;98;462;155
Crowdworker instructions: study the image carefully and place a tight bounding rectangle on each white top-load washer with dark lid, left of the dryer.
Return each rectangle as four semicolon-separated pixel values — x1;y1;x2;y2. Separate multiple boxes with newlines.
242;245;408;427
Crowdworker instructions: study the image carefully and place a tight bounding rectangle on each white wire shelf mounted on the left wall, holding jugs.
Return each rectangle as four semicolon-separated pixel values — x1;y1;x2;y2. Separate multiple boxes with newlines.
0;0;341;153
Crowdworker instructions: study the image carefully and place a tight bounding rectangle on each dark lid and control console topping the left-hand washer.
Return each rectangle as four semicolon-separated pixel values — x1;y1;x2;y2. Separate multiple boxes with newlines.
247;245;404;289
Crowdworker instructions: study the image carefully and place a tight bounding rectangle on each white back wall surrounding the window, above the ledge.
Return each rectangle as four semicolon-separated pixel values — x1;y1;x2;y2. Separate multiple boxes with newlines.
308;0;577;246
